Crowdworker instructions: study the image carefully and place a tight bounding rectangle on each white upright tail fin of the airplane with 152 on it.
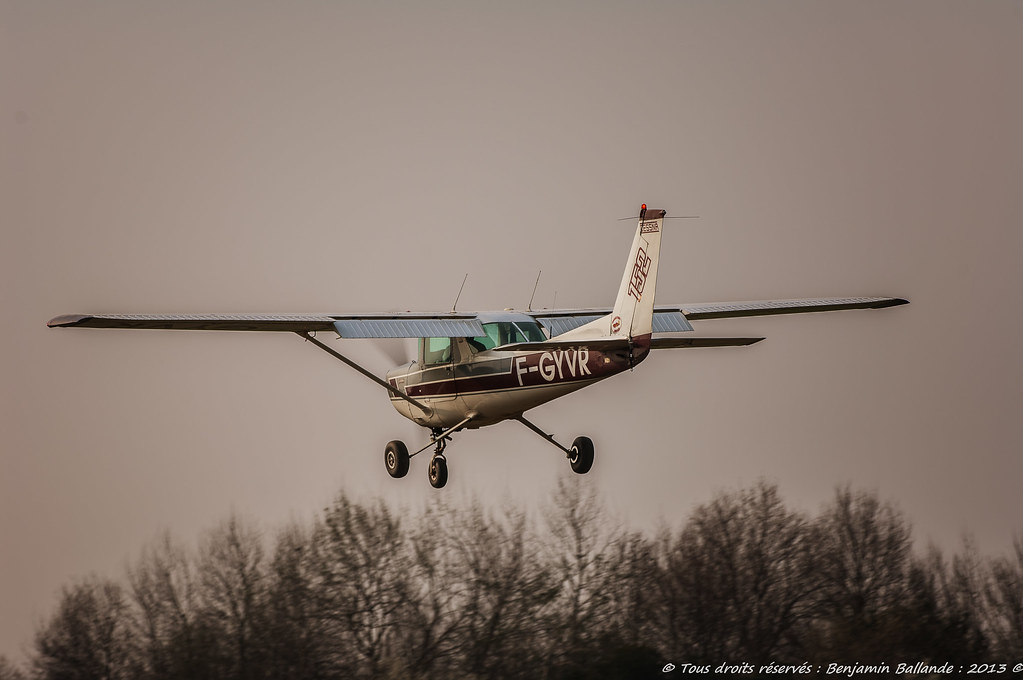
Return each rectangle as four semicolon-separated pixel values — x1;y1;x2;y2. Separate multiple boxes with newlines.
559;203;665;339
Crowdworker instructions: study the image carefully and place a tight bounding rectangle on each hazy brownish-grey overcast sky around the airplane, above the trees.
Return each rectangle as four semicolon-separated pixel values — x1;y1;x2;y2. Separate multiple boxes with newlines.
0;0;1023;656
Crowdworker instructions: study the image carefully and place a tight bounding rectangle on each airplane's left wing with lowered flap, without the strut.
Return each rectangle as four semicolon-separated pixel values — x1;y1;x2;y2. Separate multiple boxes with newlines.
46;312;484;337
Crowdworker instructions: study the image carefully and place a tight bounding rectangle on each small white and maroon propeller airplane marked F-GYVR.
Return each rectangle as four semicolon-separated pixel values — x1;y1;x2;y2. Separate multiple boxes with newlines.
47;203;907;489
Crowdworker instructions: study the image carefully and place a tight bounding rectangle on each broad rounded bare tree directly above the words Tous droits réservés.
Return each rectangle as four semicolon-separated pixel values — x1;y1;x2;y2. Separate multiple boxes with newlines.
661;482;819;663
